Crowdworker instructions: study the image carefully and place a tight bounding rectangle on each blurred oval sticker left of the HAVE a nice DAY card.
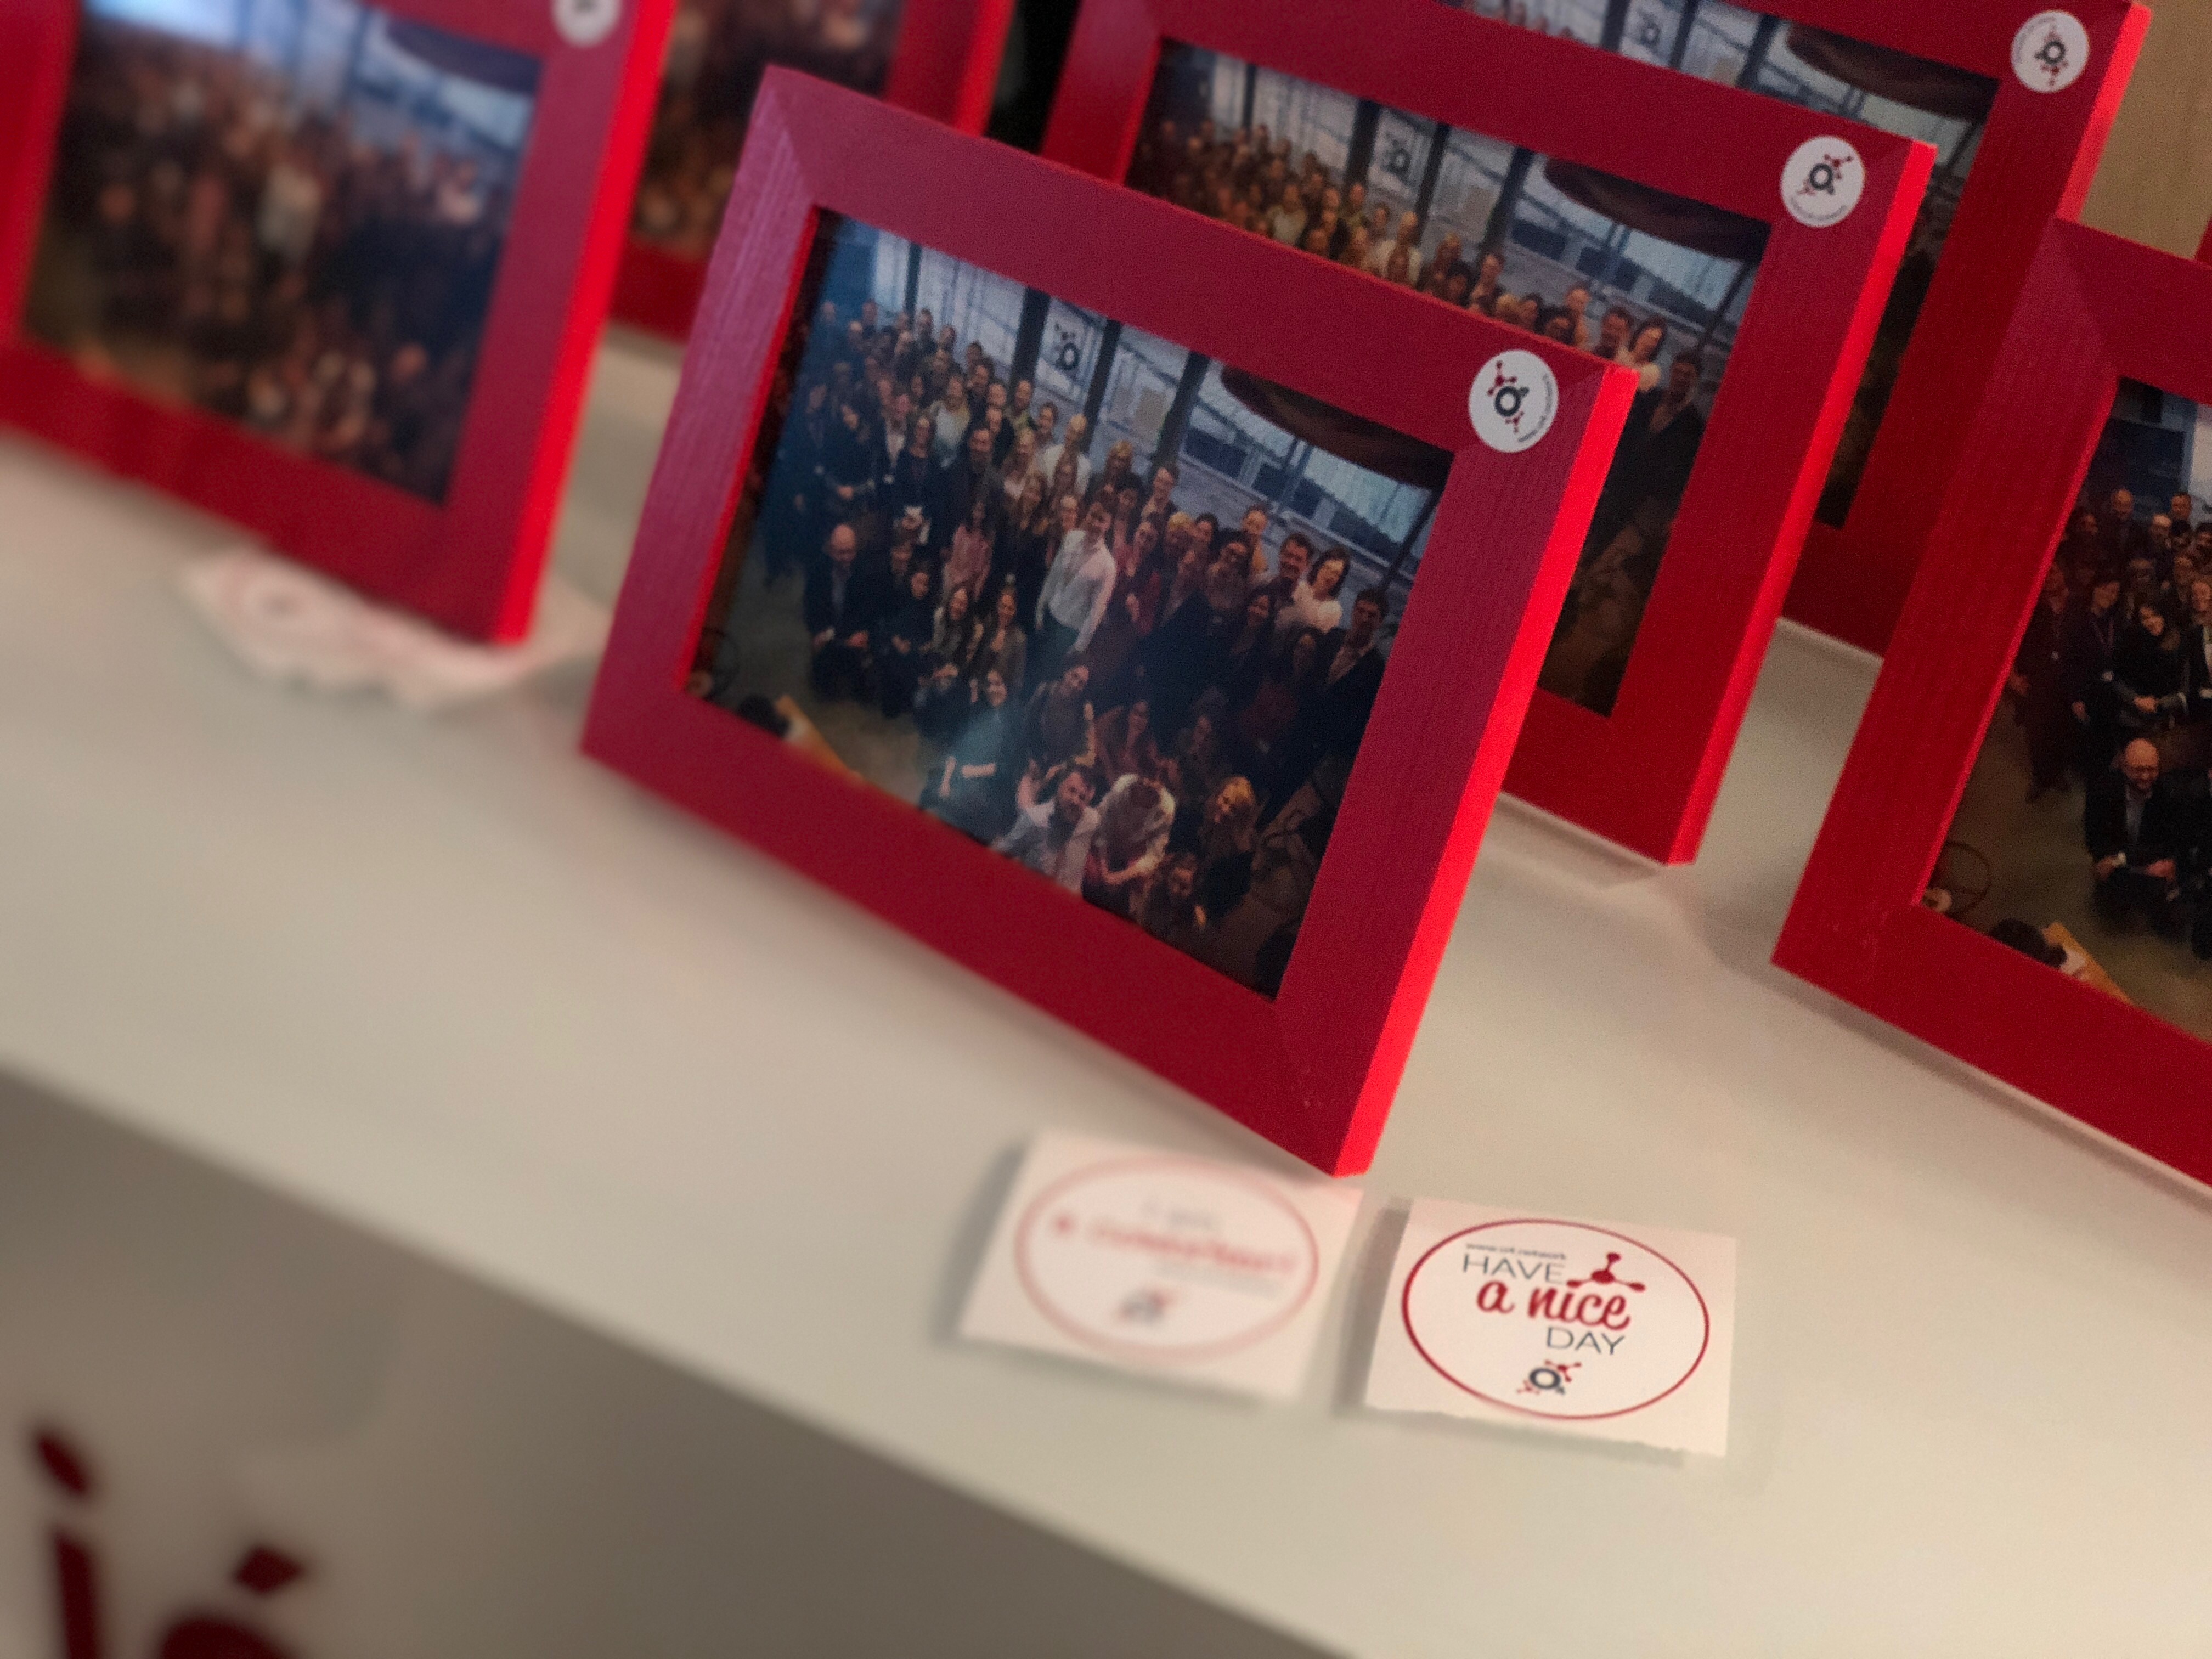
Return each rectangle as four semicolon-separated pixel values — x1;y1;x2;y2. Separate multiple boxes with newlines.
1013;1157;1321;1363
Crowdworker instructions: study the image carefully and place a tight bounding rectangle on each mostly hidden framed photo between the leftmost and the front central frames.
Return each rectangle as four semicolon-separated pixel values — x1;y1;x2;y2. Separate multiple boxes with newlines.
615;0;1013;338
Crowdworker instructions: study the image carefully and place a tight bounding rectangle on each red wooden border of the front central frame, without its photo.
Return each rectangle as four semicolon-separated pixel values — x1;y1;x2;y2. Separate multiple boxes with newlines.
584;71;1635;1175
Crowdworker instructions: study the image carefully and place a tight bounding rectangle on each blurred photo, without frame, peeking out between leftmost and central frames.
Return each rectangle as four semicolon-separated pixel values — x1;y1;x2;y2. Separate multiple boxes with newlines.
630;0;907;259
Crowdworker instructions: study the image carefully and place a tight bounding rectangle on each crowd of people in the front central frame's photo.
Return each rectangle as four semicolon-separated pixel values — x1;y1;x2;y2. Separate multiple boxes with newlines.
692;292;1387;993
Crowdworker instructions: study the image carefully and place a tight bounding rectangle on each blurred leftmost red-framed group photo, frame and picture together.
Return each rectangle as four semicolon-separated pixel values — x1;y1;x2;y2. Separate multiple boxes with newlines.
0;0;670;639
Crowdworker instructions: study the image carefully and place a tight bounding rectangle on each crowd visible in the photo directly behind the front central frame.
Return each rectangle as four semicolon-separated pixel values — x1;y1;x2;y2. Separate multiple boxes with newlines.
1128;120;1708;712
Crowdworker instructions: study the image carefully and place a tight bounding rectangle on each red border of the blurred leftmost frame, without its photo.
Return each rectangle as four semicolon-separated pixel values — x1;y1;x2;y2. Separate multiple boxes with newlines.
0;0;673;639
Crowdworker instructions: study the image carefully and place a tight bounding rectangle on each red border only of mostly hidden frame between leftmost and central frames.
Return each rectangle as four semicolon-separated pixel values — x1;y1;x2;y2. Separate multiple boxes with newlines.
613;0;1015;341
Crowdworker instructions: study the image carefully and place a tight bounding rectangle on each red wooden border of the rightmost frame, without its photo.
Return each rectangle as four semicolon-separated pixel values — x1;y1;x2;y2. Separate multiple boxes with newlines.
1774;223;2212;1179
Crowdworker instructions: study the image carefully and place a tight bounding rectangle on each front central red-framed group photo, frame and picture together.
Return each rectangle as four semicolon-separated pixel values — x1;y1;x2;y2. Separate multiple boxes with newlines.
584;71;1635;1175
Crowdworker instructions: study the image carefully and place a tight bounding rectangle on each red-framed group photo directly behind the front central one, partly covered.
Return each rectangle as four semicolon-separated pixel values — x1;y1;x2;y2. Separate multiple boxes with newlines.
1046;0;1933;862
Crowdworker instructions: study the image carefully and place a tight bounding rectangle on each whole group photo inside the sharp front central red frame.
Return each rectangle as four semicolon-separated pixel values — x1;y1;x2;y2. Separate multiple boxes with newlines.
690;221;1449;995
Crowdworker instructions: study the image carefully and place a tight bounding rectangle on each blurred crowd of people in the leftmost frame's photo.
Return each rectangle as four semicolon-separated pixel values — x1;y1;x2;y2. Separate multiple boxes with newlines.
29;18;511;500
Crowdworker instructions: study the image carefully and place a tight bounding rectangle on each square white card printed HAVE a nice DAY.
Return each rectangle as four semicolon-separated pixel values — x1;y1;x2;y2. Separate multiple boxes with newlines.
1367;1199;1736;1458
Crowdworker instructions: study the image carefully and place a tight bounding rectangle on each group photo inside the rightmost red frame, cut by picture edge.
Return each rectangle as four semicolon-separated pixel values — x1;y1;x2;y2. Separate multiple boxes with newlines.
1929;383;2212;1037
